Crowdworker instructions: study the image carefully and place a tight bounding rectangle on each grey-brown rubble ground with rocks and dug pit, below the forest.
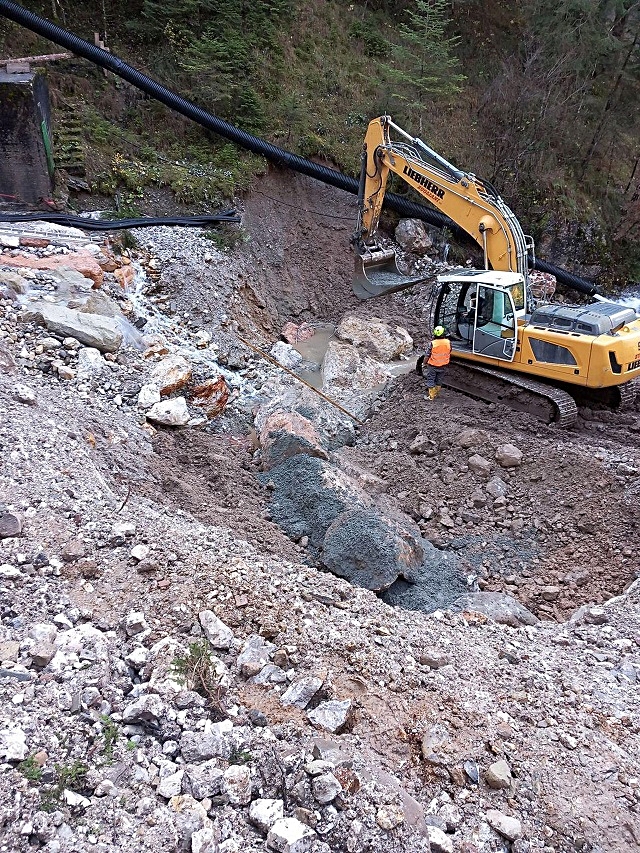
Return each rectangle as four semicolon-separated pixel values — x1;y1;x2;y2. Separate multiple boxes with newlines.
0;171;640;853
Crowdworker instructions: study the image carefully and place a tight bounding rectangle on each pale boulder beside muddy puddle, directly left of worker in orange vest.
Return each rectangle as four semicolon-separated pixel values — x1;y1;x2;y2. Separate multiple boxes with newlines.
322;341;392;419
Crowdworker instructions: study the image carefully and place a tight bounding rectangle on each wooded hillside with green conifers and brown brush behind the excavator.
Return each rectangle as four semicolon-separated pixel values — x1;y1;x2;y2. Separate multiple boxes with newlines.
0;0;640;285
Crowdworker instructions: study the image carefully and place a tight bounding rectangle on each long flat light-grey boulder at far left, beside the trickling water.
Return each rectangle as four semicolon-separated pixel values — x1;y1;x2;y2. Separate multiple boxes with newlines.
23;301;122;352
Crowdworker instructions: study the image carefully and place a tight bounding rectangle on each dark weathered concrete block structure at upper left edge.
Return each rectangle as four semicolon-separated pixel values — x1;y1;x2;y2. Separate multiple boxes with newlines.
0;71;53;204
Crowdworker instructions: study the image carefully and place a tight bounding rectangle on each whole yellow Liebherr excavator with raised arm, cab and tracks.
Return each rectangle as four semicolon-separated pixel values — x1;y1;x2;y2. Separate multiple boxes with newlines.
352;116;640;426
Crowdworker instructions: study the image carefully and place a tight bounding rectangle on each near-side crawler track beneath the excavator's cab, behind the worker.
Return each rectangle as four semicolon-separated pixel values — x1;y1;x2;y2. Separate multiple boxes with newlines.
444;361;578;429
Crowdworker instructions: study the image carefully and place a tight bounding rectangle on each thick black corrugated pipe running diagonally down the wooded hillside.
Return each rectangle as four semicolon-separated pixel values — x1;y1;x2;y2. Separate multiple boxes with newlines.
0;0;597;296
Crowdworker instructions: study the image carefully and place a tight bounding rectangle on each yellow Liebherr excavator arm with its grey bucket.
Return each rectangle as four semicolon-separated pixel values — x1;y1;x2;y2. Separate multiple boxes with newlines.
353;116;533;299
